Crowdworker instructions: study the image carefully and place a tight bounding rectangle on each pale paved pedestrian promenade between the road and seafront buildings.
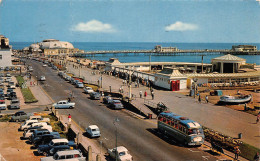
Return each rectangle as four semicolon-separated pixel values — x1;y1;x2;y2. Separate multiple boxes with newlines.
67;63;260;148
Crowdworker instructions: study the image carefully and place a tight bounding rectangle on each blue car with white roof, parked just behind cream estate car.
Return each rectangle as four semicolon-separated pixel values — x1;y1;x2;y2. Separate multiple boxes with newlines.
37;138;76;154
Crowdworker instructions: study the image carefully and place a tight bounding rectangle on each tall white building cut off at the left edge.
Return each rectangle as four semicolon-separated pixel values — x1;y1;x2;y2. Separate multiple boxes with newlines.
0;35;12;67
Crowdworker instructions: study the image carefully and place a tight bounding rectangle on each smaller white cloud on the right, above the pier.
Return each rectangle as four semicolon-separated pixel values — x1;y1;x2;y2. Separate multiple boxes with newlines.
165;21;199;31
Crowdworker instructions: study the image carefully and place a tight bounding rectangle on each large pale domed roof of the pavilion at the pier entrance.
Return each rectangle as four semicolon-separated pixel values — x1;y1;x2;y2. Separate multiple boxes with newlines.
40;39;74;49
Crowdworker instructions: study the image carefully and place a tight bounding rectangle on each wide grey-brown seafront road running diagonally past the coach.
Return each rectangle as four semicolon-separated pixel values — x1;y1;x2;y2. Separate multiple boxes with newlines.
25;61;222;161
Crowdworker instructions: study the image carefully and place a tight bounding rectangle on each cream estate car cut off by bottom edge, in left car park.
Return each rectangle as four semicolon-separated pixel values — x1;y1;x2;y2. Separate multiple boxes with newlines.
41;150;86;161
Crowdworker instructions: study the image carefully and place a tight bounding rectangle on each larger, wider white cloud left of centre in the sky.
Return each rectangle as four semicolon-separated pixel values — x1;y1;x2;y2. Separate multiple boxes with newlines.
72;20;116;33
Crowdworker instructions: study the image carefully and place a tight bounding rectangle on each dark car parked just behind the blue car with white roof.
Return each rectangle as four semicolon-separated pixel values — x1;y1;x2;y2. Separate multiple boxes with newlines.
33;132;60;147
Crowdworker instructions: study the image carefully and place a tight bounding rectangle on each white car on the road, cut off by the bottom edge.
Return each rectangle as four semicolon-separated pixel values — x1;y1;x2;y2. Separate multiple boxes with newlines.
107;146;133;161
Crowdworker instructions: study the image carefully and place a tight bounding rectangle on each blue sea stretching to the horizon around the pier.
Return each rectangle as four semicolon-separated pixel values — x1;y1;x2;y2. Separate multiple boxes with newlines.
10;42;260;65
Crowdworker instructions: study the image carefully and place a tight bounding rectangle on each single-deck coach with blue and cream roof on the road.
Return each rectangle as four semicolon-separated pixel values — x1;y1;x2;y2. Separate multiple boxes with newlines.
158;111;205;146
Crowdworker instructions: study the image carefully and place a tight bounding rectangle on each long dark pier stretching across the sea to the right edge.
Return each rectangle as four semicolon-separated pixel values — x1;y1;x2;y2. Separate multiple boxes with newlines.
71;49;260;57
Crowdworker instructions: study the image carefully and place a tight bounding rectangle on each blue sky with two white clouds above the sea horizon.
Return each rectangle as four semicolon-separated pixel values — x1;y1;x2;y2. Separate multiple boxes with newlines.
0;0;260;43
